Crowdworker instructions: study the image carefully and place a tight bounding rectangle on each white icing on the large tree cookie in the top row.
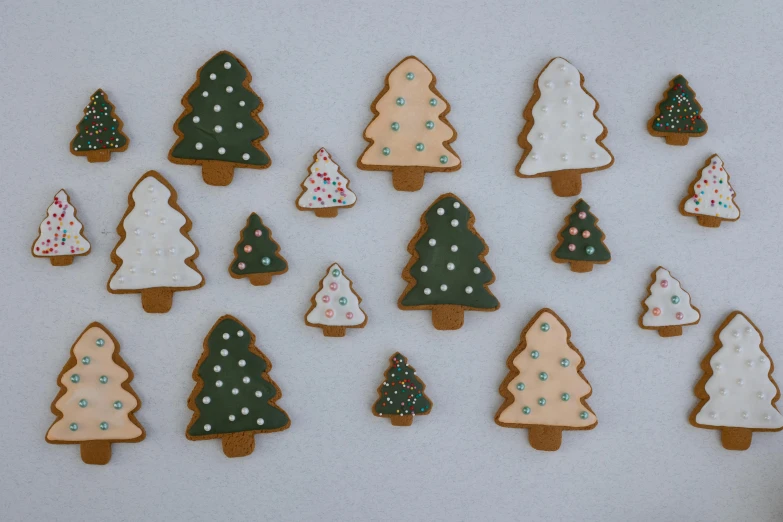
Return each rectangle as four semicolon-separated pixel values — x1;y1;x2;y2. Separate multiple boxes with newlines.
519;58;612;176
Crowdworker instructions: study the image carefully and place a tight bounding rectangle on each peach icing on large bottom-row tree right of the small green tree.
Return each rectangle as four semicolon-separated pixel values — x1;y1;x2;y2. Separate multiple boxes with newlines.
497;311;597;428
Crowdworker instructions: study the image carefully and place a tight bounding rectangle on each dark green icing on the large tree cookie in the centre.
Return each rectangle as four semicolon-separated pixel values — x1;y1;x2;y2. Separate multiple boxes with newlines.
401;196;498;309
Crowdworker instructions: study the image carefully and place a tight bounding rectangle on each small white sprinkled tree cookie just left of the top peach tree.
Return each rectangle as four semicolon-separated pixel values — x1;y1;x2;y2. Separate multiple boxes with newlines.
296;147;356;217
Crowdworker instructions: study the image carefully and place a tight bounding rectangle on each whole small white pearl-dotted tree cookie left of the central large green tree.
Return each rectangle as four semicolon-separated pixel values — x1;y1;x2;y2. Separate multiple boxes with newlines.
305;263;367;337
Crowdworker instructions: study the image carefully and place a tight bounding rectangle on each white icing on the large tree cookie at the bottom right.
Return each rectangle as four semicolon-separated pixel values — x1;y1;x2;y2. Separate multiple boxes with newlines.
696;313;783;429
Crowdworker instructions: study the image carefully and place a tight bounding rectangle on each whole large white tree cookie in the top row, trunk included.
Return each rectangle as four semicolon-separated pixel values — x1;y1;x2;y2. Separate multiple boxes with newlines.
517;58;614;196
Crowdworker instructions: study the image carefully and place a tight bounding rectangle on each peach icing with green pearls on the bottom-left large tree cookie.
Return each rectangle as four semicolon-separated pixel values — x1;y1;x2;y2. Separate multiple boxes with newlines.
46;326;142;442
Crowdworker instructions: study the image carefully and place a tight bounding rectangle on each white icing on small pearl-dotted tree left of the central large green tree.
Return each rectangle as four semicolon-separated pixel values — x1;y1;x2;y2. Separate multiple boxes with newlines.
307;263;365;326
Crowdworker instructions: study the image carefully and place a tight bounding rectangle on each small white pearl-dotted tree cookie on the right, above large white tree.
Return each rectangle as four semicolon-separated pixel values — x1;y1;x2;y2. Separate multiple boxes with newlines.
639;266;700;337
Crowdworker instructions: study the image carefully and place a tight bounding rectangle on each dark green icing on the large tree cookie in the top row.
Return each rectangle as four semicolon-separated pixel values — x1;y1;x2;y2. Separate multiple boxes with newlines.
171;53;269;165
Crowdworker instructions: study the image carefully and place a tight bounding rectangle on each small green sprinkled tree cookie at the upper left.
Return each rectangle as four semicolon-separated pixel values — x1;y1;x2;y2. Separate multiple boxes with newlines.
70;89;130;163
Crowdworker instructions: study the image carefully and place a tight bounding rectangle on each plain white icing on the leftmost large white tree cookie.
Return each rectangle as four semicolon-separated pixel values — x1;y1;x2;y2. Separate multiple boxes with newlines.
109;176;202;290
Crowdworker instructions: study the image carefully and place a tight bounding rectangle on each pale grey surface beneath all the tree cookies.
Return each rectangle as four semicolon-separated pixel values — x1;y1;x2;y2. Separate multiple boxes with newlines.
0;0;783;521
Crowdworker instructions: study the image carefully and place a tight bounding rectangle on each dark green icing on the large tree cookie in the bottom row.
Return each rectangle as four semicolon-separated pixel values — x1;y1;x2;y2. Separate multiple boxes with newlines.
188;318;288;437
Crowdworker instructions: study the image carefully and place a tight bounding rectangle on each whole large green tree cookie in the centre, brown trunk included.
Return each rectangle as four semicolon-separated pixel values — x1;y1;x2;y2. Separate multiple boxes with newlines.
397;193;500;330
